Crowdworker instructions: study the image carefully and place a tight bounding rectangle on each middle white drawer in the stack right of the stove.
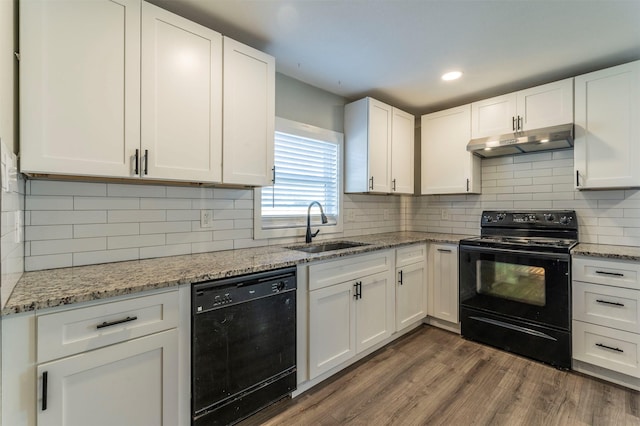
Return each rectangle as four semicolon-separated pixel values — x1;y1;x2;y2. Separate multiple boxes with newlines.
573;281;640;333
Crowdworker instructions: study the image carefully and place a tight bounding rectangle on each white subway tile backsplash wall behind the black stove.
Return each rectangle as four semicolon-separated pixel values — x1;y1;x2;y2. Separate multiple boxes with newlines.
405;150;640;246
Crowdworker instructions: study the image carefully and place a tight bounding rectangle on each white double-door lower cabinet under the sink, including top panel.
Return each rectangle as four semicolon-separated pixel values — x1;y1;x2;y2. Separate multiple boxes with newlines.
309;251;395;379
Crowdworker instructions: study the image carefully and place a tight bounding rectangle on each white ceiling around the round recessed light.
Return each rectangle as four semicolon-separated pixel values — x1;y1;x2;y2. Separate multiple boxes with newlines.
146;0;640;114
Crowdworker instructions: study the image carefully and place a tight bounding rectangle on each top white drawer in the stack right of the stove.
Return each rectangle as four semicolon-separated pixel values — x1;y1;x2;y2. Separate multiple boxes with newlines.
572;256;640;290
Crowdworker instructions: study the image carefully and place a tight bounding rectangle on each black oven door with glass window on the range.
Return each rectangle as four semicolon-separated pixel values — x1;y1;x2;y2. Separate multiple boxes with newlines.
459;244;571;330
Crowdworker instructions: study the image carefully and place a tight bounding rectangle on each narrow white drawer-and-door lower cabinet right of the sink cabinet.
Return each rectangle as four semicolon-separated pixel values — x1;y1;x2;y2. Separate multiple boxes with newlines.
396;244;427;331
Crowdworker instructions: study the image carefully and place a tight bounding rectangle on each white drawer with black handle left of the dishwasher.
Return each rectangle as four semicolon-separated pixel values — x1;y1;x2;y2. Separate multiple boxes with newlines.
37;291;179;363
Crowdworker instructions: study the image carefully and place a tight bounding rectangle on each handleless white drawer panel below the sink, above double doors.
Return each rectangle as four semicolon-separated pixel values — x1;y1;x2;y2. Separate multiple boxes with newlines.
309;250;392;290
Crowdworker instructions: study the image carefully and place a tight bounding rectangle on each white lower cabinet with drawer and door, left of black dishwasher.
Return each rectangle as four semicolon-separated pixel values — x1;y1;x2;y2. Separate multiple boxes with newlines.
36;291;181;426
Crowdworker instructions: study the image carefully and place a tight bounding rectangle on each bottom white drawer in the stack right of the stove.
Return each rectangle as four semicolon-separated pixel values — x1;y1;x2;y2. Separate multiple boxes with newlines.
572;321;640;377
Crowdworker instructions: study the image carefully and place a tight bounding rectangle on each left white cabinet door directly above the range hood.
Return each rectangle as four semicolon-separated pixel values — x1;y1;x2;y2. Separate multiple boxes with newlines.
471;93;517;139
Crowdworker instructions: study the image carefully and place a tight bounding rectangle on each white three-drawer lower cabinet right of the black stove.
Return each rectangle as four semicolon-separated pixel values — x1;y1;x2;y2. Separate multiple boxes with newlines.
572;256;640;390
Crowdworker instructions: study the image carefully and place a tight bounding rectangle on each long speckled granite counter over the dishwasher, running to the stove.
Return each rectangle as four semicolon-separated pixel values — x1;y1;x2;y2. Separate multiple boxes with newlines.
2;232;467;315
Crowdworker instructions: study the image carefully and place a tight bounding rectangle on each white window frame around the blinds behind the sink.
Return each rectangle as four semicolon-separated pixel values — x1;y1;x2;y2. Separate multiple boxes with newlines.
253;117;344;240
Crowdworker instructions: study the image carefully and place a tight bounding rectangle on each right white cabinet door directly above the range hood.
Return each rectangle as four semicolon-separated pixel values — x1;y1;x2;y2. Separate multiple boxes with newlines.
518;78;573;130
